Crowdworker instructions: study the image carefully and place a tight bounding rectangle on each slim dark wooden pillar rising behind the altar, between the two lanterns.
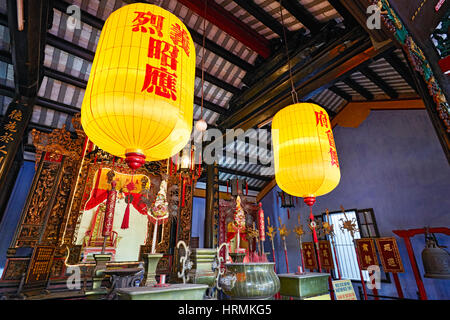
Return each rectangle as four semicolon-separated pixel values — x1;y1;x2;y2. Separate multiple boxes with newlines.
203;163;219;248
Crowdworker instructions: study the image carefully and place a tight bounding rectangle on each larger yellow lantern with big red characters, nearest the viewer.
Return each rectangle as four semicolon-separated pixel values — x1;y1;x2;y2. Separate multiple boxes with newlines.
81;3;196;169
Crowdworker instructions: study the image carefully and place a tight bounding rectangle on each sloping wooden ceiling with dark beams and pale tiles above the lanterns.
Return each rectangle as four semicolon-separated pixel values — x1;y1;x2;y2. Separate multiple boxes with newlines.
0;0;418;194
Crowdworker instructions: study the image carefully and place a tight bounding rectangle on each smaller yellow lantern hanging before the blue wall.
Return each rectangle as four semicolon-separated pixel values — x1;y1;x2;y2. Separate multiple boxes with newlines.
272;103;341;206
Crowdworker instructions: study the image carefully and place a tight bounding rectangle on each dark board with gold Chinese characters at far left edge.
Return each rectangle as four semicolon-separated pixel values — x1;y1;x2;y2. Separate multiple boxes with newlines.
0;97;35;221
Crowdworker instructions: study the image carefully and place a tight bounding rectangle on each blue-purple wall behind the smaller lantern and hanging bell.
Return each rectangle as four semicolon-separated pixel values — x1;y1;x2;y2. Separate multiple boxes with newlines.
262;110;450;299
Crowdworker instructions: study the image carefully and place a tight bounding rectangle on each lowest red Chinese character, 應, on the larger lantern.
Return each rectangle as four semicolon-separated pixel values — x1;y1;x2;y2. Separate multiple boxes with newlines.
141;64;177;101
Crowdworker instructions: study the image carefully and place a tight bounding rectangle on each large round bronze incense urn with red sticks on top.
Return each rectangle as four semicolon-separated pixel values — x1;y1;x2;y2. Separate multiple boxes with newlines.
220;262;280;300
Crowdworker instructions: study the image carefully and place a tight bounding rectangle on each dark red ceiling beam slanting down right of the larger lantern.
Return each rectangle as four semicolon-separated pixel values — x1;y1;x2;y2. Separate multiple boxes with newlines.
178;0;271;59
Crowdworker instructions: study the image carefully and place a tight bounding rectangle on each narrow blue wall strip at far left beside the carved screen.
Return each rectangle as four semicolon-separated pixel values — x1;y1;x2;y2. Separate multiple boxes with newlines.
0;161;34;277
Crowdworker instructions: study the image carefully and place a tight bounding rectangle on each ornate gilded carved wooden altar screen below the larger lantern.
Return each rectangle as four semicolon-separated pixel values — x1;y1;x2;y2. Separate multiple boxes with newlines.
1;115;195;282
